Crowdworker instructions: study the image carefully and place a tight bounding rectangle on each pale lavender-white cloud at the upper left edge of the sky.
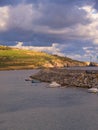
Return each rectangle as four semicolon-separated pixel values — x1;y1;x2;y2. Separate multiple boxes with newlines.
0;3;41;31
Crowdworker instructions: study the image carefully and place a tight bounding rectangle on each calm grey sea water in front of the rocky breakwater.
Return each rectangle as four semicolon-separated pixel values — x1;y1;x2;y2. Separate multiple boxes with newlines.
0;70;98;130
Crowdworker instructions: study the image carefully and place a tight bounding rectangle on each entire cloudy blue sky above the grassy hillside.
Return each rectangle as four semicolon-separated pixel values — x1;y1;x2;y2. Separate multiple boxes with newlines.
0;0;98;62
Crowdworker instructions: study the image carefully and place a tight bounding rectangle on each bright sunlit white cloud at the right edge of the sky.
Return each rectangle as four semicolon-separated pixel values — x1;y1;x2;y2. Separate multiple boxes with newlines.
78;6;98;44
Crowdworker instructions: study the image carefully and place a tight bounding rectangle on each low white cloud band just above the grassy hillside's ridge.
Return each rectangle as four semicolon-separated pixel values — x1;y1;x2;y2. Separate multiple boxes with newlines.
11;42;90;61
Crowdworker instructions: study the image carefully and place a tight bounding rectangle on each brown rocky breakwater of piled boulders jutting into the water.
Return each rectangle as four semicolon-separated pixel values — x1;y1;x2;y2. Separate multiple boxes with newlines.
30;68;98;88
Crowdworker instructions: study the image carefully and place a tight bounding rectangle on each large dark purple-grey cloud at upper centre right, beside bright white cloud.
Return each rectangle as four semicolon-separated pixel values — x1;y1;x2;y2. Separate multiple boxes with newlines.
35;4;90;28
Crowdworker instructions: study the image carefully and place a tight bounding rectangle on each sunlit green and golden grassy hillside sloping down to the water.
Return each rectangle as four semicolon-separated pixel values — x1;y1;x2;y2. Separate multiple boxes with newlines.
0;46;86;70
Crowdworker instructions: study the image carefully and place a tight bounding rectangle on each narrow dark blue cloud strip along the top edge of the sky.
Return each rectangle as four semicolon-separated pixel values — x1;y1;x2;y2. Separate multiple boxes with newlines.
0;0;94;7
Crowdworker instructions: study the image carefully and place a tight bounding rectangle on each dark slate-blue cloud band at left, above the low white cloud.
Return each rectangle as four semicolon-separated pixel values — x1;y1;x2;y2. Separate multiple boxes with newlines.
0;29;63;46
